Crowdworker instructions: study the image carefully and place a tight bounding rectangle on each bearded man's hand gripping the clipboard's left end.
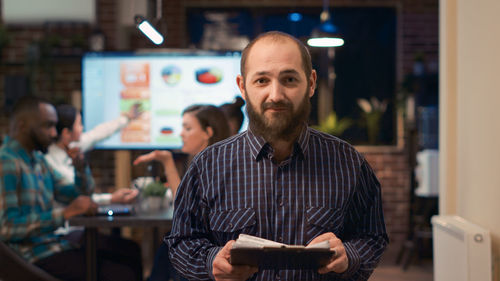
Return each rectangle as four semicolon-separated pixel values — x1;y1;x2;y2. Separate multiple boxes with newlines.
212;240;259;281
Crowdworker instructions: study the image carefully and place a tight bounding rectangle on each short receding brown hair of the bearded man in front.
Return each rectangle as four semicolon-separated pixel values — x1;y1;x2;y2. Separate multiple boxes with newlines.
240;31;312;79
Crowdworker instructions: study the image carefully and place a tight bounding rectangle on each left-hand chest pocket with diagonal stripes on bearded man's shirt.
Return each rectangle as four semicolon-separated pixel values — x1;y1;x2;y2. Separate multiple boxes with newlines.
209;208;257;243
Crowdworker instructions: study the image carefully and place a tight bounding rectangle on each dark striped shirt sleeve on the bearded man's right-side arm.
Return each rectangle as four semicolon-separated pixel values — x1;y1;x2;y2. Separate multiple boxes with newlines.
337;160;389;280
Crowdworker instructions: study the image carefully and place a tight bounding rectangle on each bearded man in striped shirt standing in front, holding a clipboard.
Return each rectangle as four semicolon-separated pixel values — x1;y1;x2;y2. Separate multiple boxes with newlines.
165;32;388;280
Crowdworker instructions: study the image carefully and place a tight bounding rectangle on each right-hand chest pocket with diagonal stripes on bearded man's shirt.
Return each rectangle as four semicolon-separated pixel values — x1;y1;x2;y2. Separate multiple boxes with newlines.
306;203;344;242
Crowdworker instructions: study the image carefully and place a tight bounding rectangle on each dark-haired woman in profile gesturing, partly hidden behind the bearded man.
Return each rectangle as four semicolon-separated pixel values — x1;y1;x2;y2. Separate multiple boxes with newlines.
134;105;229;281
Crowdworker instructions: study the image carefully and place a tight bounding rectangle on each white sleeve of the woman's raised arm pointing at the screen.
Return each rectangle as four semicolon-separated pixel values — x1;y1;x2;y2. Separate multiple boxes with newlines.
75;116;129;153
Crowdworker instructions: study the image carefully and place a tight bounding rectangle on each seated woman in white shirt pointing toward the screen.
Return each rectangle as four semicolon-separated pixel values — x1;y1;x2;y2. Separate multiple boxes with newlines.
45;104;140;208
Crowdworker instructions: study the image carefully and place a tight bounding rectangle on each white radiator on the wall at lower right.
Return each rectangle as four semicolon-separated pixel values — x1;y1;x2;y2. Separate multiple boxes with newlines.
432;216;492;281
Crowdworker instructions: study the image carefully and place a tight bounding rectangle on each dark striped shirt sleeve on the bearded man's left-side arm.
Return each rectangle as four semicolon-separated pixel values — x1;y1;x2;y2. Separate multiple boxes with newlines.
165;162;219;280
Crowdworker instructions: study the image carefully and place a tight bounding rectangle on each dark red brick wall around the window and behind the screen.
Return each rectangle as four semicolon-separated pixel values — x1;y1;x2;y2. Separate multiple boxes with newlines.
0;0;438;249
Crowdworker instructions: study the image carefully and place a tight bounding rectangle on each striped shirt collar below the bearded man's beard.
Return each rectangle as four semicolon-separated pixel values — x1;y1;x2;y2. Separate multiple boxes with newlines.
246;124;310;161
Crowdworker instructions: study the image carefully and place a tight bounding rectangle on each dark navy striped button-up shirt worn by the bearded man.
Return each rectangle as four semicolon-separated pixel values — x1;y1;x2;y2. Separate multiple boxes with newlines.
165;128;388;280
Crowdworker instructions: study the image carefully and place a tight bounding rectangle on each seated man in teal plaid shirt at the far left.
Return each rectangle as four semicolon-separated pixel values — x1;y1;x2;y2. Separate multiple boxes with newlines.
0;97;142;280
